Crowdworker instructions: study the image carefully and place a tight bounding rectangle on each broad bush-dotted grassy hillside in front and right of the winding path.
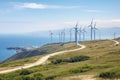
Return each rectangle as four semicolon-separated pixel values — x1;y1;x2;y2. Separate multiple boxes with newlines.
0;39;120;80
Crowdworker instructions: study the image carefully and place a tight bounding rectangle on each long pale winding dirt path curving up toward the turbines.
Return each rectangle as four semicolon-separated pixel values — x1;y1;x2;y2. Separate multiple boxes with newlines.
0;44;86;74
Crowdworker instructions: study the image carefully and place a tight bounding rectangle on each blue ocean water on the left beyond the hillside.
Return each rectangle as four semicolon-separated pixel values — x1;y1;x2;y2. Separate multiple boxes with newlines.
0;35;57;62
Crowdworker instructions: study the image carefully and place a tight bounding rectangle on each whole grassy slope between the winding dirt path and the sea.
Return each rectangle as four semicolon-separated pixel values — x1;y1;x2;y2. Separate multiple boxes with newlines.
0;43;77;70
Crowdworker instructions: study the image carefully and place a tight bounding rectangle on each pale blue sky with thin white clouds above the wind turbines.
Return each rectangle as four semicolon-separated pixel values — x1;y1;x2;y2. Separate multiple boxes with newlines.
0;0;120;34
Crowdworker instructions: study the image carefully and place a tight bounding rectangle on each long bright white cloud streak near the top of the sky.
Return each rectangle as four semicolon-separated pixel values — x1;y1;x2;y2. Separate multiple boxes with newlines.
14;3;80;9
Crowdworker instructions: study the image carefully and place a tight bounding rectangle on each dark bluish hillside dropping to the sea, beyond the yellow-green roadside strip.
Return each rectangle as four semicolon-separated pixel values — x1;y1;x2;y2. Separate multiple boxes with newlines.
3;43;75;62
